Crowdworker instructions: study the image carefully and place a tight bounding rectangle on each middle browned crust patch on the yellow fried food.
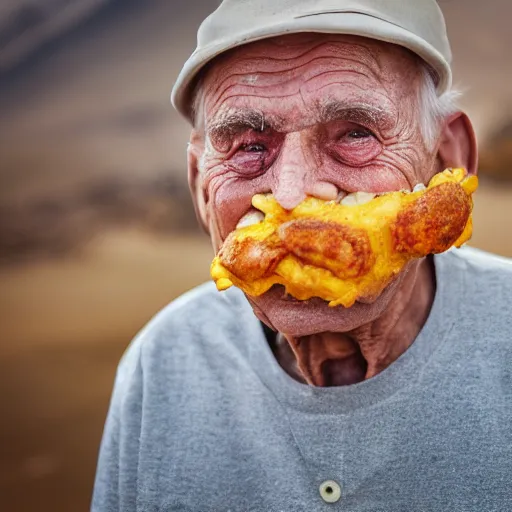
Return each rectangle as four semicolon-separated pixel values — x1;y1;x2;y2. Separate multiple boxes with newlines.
278;219;373;279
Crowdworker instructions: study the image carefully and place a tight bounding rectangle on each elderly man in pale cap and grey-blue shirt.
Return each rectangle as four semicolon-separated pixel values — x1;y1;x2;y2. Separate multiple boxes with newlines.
92;0;512;512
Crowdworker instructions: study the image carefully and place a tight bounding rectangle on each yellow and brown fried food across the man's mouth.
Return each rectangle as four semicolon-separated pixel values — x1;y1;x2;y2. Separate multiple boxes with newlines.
211;169;478;307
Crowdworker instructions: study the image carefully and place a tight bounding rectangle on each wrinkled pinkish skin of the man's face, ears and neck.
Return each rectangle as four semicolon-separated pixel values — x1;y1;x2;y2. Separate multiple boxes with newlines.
188;34;477;386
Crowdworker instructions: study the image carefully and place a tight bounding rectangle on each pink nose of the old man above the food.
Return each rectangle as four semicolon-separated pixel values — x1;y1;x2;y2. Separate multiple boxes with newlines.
271;133;312;210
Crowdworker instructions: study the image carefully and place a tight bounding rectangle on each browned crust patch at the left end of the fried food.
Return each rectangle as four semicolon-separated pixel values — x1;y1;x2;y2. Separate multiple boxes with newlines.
219;231;288;282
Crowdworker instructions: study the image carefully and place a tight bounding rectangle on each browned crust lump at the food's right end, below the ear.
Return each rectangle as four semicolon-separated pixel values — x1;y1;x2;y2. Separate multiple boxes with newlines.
391;183;471;257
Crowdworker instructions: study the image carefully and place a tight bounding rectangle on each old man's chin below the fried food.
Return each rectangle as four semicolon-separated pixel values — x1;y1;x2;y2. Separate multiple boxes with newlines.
246;271;406;337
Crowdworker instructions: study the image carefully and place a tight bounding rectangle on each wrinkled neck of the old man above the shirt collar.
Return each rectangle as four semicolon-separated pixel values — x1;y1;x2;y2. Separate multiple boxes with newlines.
273;258;435;386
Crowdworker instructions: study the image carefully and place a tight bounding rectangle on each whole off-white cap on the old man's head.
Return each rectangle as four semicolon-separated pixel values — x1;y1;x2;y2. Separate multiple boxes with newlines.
171;0;452;120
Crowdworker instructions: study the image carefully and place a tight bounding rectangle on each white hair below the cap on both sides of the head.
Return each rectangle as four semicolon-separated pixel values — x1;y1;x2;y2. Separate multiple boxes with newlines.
191;61;462;151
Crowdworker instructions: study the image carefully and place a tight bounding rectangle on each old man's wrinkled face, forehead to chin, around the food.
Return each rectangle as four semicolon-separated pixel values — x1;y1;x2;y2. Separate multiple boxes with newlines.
195;34;440;336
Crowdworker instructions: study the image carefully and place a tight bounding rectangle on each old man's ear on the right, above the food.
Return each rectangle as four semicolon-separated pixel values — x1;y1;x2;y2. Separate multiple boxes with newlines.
437;112;478;174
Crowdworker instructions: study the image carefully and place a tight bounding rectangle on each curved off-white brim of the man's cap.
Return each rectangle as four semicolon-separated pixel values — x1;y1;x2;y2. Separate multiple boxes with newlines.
171;12;452;121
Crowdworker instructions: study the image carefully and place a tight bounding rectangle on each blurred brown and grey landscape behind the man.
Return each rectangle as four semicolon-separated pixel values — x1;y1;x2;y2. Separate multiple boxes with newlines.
0;0;512;512
